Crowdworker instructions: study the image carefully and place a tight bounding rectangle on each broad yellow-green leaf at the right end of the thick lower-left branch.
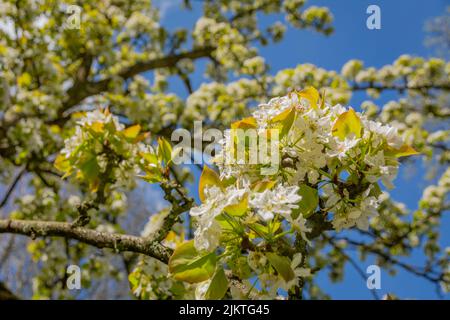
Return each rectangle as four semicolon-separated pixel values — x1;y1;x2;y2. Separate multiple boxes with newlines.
169;240;217;283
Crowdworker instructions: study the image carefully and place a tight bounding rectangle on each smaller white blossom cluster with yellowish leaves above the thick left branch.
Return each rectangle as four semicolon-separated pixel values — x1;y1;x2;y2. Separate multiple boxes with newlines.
55;110;145;191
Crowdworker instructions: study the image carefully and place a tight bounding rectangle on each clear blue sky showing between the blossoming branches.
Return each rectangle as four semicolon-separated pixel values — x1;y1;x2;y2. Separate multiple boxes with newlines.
155;0;450;299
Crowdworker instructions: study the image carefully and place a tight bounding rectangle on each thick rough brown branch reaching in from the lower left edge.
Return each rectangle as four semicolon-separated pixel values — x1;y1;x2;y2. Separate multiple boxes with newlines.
0;219;172;263
